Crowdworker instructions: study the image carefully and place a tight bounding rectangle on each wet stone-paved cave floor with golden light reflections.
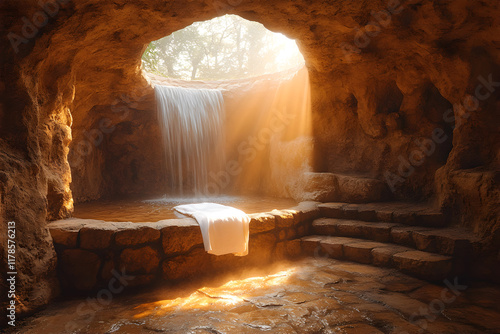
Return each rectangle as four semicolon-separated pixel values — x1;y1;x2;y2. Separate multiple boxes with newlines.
8;258;500;334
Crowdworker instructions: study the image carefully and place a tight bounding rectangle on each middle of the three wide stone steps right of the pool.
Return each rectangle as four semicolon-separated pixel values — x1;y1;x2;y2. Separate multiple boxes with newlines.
312;218;480;257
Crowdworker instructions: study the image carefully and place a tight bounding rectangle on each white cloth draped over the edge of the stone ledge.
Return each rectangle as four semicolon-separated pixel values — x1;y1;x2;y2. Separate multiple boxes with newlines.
174;203;250;256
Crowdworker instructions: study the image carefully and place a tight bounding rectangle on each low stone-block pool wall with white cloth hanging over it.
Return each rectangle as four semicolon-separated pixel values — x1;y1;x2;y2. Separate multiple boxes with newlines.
48;202;312;291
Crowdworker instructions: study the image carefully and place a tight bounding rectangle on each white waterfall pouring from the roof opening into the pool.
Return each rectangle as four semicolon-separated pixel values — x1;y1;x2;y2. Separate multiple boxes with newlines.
155;85;225;196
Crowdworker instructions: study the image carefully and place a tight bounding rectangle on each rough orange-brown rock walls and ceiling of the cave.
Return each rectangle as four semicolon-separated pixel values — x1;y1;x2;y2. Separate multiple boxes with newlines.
0;0;500;318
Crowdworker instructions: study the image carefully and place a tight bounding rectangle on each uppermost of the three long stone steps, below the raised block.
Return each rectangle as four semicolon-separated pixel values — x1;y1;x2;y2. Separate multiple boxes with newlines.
318;202;448;227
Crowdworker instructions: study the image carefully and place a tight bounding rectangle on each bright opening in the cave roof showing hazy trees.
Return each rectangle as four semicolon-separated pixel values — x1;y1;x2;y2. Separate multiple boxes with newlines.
142;15;303;80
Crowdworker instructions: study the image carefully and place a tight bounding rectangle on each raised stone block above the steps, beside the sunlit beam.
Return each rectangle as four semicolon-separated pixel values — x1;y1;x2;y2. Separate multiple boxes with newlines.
296;172;391;203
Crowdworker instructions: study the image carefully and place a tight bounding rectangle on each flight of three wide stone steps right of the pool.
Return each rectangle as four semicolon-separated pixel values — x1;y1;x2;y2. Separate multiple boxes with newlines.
294;202;479;281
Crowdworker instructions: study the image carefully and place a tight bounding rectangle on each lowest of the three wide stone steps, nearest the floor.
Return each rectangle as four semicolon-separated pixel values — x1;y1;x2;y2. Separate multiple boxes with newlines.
300;235;463;281
